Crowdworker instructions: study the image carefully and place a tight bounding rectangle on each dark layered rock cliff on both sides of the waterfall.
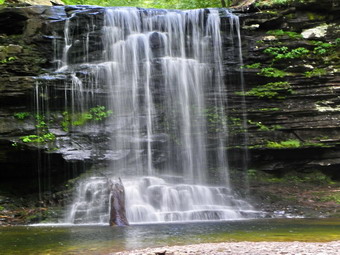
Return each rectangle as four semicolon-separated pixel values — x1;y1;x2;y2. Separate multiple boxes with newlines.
0;1;340;219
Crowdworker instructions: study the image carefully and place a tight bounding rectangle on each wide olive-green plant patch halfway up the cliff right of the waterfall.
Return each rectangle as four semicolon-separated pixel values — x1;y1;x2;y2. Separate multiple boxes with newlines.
236;82;293;99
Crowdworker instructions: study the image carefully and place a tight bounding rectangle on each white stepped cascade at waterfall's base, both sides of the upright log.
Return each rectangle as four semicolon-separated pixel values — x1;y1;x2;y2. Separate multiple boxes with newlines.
67;176;258;224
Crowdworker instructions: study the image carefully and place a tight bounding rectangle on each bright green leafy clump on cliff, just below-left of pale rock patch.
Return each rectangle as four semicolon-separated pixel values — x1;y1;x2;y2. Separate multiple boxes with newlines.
264;46;309;61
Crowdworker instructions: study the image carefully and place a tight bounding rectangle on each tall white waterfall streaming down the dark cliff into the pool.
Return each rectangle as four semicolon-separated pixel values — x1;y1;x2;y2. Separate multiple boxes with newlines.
44;8;252;223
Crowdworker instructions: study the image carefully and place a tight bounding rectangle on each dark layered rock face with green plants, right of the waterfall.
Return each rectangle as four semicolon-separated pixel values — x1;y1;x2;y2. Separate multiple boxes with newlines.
234;1;340;178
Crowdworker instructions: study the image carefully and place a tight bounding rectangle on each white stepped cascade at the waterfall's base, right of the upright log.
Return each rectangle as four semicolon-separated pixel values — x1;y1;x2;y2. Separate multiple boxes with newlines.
125;177;255;224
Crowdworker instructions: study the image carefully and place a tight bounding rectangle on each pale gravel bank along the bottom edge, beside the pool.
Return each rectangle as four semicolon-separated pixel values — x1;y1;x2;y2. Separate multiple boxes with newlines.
112;241;340;255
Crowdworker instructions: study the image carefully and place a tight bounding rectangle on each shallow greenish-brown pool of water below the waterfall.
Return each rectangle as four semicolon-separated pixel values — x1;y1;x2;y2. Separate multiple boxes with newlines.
0;219;340;254
